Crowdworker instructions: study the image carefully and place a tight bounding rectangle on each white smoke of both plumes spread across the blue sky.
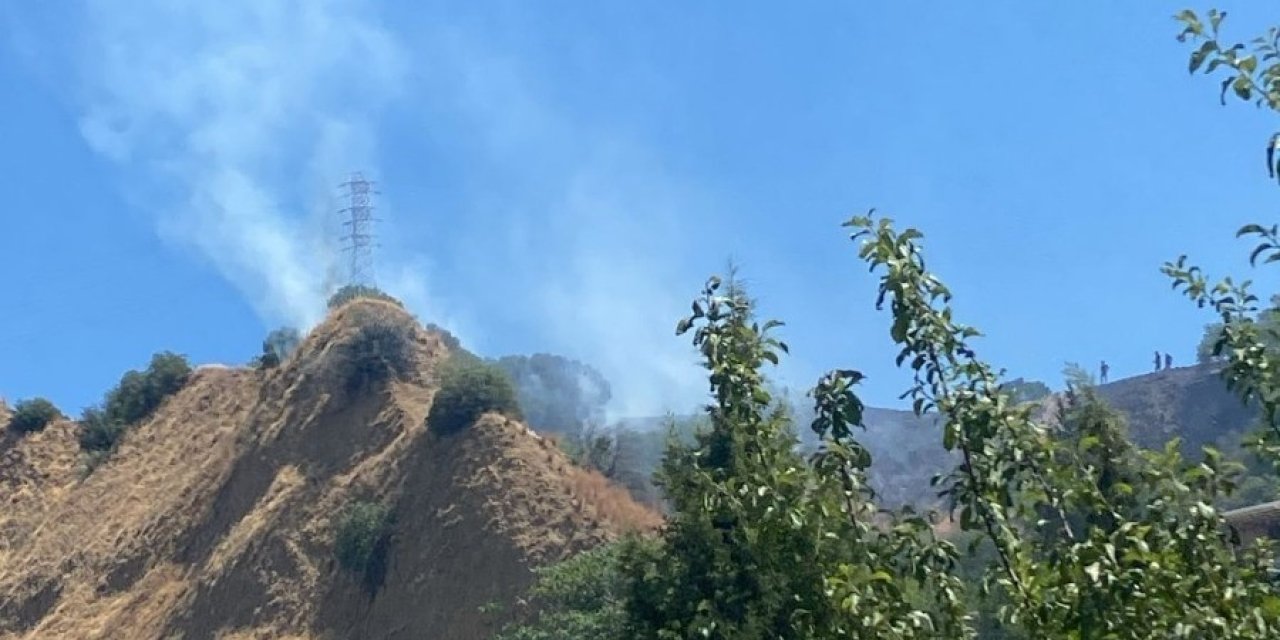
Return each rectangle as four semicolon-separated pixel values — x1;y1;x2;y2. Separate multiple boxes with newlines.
47;0;722;415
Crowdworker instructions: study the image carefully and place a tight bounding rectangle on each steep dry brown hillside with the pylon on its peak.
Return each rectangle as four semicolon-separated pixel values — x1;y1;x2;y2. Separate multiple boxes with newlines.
0;300;658;640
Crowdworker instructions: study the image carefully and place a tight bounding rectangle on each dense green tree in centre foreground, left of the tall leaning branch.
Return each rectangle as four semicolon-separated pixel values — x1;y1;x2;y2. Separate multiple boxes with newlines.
622;278;969;640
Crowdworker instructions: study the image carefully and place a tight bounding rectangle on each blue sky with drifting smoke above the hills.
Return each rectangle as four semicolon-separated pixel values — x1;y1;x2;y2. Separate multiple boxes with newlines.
0;0;1280;415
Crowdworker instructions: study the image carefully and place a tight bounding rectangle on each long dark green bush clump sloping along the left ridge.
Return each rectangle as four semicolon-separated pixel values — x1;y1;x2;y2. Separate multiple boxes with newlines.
79;351;191;452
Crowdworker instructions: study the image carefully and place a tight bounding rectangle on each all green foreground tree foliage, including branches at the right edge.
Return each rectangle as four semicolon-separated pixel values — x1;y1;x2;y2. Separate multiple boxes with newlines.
506;12;1280;640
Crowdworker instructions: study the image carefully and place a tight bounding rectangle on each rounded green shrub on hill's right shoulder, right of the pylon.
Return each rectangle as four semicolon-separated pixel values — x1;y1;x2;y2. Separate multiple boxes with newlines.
426;360;520;434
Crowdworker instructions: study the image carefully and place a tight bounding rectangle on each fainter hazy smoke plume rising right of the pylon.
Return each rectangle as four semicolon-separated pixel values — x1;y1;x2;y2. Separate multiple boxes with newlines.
413;38;723;420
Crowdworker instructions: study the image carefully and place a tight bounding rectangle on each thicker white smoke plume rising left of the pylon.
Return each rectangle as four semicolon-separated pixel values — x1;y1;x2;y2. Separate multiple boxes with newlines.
78;0;402;326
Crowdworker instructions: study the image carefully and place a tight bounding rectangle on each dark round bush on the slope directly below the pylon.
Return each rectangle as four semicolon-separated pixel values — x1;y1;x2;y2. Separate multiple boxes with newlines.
338;317;413;394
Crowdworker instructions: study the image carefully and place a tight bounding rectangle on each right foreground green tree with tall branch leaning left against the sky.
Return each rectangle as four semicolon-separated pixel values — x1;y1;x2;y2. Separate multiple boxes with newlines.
849;216;1280;639
